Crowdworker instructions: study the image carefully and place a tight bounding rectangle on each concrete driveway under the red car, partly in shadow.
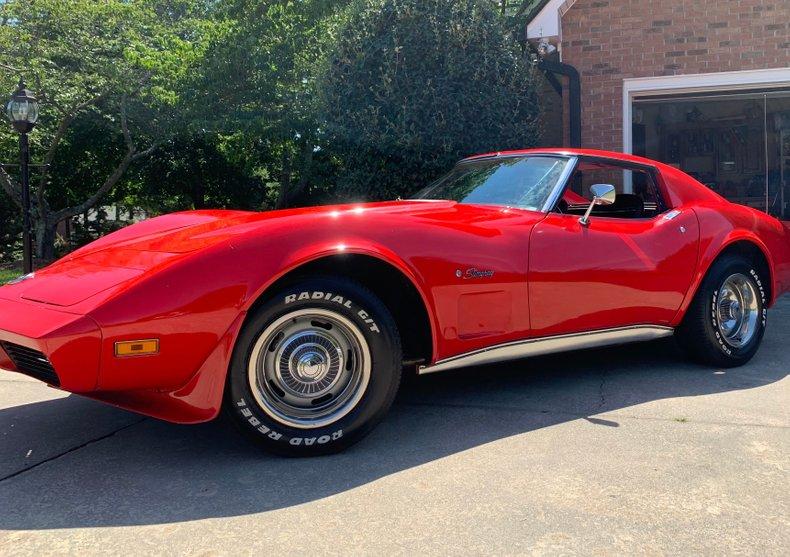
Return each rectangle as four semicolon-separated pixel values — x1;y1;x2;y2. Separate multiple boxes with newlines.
0;299;790;555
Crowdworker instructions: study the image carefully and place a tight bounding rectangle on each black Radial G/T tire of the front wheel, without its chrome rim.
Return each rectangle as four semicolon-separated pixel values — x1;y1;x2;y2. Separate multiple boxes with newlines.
224;278;401;456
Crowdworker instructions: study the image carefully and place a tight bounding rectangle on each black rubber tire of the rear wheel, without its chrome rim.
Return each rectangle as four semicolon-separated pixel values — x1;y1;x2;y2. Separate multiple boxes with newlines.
703;257;768;365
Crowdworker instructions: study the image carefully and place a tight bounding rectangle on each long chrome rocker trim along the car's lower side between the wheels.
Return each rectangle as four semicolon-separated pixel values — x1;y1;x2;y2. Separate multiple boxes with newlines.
417;325;675;375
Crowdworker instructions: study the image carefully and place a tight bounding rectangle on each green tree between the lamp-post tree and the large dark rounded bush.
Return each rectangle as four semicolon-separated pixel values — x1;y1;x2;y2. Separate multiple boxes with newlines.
190;0;348;208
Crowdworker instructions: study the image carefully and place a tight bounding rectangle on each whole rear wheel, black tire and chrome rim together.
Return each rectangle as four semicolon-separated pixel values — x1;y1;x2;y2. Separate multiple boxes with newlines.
677;255;767;367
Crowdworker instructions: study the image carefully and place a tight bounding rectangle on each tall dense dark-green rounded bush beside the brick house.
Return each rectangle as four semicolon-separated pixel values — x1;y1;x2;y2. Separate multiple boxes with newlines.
318;0;540;199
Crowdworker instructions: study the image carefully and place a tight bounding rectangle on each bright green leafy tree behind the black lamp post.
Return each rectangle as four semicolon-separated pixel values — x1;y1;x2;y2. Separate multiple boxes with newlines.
0;0;211;259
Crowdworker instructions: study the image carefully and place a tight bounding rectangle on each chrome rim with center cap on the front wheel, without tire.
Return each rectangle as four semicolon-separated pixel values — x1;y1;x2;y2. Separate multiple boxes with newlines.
248;309;371;428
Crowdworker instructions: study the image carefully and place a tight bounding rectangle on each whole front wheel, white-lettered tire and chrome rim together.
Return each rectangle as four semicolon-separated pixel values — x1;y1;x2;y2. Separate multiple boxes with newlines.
225;278;401;456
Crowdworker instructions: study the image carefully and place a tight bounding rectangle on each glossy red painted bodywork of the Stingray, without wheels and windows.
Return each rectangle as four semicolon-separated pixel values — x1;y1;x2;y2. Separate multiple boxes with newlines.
0;149;790;423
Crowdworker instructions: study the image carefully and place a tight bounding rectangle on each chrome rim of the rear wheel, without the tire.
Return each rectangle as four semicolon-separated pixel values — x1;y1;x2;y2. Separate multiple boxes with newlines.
716;273;760;348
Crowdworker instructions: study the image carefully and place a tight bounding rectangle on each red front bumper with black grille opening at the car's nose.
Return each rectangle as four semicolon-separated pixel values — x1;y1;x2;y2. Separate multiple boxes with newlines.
0;299;102;392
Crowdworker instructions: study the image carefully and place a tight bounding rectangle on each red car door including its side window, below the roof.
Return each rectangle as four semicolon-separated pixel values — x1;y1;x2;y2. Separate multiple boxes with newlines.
528;159;699;337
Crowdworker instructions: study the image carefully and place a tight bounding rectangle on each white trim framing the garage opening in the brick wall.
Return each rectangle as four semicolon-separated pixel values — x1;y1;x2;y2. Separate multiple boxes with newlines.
623;68;790;153
